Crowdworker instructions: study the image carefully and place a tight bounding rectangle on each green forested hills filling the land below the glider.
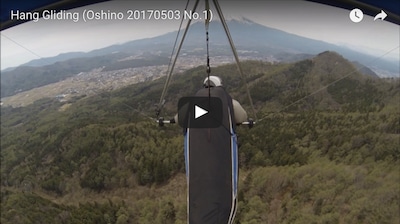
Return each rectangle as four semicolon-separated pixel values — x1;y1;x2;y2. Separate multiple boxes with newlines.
0;52;400;224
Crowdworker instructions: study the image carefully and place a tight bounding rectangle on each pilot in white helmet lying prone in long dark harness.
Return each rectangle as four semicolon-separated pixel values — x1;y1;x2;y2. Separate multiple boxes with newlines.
174;76;247;224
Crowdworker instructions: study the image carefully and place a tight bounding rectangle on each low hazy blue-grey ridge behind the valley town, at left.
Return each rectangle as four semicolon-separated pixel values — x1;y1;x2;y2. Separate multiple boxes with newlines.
1;52;169;97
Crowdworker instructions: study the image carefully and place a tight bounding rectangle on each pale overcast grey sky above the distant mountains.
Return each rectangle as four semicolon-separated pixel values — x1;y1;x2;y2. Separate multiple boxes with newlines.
1;0;400;70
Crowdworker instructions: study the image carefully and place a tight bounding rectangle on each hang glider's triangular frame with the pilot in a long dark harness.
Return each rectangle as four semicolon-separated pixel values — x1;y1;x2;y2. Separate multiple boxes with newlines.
156;0;253;221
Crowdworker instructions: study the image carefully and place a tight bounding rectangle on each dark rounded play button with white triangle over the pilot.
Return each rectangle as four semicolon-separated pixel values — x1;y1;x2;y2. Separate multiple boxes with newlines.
178;97;222;128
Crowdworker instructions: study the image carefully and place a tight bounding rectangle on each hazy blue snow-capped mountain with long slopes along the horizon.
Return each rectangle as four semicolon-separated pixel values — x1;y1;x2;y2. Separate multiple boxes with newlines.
12;18;399;74
